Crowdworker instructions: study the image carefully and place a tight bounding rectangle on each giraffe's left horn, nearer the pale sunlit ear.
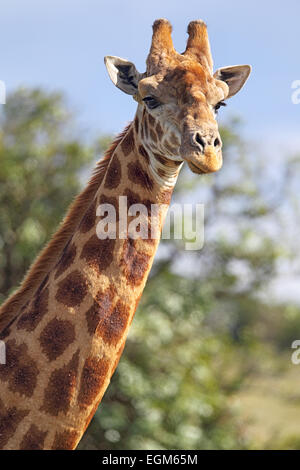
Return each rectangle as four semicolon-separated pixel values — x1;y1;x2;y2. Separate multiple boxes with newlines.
147;18;176;73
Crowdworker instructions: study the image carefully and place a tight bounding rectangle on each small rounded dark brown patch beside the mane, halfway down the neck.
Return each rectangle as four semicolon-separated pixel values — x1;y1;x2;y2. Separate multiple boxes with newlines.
55;270;88;307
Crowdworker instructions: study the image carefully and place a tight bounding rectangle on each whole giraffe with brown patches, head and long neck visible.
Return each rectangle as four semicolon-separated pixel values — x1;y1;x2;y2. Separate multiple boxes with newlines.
0;19;250;450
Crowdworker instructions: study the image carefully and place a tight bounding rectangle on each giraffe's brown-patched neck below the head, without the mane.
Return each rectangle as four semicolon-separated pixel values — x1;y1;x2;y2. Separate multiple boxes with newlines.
0;110;183;449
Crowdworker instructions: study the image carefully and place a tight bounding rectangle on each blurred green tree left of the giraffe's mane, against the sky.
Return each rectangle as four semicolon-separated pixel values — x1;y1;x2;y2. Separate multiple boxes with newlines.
0;89;92;302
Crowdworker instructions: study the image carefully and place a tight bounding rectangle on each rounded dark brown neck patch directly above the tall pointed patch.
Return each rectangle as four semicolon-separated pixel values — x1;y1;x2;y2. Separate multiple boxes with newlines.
39;318;75;361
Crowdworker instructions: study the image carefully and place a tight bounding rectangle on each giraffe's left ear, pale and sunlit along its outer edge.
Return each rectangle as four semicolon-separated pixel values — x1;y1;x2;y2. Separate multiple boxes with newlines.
104;55;142;95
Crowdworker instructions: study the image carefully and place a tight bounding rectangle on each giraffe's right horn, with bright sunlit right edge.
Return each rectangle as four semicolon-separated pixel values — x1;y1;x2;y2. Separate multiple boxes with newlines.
184;20;213;73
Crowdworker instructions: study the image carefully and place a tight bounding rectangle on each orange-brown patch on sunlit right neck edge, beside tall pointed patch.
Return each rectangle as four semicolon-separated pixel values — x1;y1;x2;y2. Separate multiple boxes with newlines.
78;357;110;407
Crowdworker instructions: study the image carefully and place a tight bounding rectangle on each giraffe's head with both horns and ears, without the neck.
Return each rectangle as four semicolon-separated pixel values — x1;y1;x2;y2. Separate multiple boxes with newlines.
105;19;251;173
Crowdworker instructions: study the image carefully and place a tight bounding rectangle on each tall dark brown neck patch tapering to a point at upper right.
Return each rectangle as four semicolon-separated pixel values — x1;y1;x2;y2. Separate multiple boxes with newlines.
41;349;79;416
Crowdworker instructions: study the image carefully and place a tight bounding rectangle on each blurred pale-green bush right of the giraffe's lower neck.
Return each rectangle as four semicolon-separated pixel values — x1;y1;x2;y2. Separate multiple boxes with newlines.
81;271;248;449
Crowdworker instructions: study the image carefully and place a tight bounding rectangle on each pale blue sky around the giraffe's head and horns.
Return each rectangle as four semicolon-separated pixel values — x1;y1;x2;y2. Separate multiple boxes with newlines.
0;0;300;149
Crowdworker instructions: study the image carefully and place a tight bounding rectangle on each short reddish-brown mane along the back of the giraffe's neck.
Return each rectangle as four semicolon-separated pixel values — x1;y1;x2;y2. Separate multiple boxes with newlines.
0;123;131;332
